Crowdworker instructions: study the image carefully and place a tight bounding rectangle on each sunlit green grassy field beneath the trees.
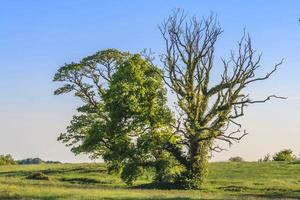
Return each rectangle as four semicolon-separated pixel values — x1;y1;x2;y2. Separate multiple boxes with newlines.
0;162;300;200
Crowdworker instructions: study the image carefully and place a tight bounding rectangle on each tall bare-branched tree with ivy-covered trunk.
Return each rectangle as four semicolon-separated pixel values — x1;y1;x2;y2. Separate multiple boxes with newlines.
159;10;282;188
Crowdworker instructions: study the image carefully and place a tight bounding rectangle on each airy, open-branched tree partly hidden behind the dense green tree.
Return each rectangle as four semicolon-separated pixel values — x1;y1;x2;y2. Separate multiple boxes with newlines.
53;49;129;158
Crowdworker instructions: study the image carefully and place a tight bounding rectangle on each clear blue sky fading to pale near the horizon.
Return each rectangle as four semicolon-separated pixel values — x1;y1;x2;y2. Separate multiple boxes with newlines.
0;0;300;162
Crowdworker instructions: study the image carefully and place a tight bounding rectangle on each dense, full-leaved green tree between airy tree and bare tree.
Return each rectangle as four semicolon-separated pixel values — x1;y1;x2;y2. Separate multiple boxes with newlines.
103;55;178;184
